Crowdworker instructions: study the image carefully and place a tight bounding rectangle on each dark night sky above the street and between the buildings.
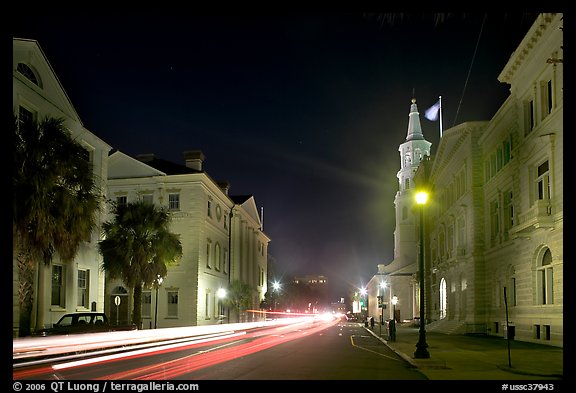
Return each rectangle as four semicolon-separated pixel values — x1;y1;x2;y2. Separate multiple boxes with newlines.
13;11;537;296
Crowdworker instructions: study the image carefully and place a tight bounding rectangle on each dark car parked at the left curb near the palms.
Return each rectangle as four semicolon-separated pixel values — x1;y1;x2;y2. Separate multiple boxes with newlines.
34;312;136;336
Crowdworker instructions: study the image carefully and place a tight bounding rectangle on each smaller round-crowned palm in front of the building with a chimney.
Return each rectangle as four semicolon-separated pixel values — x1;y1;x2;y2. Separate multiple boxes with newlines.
98;201;182;327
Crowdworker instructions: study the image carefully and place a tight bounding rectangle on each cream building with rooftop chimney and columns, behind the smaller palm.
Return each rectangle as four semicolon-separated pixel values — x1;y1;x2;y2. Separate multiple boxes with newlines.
106;151;270;329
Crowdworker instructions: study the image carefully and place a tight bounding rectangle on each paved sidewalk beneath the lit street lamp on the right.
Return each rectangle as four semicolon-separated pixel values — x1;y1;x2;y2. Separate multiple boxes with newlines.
365;324;564;380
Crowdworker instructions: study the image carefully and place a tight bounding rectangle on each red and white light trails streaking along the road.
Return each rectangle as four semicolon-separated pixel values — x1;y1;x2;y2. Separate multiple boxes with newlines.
13;314;339;380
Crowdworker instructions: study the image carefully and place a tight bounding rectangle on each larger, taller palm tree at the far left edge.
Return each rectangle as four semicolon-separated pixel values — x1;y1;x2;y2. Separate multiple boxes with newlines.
12;115;101;337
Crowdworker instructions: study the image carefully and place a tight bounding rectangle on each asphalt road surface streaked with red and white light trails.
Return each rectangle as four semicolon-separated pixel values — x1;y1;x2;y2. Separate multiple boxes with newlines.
13;321;427;381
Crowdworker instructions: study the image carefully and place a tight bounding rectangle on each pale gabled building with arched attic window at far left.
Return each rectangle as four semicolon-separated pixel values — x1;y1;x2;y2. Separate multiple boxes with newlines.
12;38;111;334
